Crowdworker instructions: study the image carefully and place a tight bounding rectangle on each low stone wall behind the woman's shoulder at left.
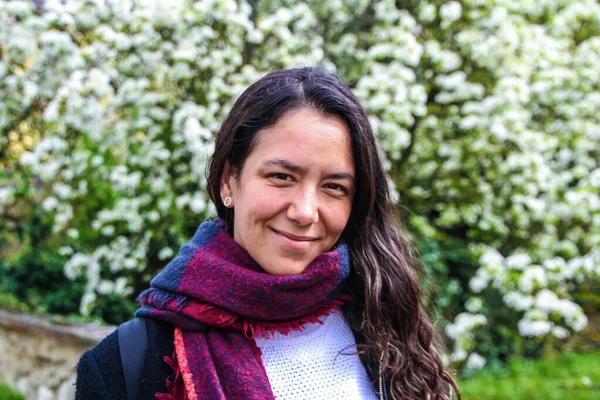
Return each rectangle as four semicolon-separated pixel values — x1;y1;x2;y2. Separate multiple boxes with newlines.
0;310;115;400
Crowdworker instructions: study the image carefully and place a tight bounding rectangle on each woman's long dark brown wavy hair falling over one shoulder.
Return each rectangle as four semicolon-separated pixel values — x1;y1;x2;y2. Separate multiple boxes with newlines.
207;68;460;400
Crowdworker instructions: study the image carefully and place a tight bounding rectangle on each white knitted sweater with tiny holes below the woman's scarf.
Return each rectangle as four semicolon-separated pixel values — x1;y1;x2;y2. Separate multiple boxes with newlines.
256;312;377;400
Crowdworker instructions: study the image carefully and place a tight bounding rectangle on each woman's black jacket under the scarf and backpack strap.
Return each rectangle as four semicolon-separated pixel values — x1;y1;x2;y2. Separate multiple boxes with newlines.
75;318;385;400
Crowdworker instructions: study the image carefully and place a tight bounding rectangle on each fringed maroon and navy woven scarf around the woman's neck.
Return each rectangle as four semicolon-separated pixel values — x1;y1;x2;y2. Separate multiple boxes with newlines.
136;219;350;400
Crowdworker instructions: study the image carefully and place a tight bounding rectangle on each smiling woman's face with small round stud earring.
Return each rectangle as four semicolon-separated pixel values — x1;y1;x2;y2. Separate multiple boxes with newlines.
221;109;355;276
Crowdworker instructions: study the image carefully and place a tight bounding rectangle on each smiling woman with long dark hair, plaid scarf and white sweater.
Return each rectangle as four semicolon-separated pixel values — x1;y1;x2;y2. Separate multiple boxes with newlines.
77;68;456;400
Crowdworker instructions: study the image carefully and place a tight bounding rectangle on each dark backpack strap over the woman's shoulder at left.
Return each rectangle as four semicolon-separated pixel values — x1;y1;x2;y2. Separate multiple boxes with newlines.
117;317;148;400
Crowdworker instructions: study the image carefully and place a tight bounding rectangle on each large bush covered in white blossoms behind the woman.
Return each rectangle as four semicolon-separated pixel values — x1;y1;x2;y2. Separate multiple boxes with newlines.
0;0;600;368
